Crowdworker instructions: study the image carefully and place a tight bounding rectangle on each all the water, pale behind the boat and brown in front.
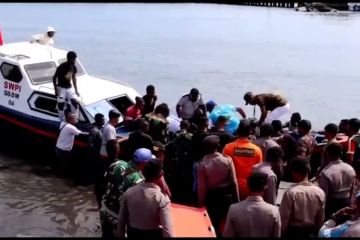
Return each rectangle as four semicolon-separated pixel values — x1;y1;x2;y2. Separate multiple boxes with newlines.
0;3;360;236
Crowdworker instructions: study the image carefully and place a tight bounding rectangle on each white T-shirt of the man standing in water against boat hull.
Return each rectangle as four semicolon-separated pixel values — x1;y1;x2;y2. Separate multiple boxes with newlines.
56;122;81;151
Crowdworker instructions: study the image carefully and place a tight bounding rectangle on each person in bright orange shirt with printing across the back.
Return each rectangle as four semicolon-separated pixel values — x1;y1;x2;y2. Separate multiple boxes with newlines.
223;119;263;200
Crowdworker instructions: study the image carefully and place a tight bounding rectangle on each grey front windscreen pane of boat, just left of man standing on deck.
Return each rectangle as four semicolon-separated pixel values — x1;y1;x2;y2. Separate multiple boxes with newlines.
24;62;56;85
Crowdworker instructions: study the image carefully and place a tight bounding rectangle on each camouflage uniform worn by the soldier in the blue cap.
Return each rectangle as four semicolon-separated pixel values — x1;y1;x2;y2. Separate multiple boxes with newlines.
100;160;144;236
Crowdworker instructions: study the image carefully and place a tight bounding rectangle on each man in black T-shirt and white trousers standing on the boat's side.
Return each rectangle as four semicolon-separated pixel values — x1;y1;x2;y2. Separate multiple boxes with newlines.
53;51;80;121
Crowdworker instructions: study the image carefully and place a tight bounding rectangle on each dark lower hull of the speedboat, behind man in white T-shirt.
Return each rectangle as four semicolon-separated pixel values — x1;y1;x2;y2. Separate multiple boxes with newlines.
0;106;95;184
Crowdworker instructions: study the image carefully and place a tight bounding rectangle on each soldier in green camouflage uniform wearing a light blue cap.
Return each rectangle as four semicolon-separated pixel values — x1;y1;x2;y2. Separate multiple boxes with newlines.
100;145;153;237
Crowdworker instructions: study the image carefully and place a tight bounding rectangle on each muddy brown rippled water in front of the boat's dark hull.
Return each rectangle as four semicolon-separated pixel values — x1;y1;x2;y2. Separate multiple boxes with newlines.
0;154;101;237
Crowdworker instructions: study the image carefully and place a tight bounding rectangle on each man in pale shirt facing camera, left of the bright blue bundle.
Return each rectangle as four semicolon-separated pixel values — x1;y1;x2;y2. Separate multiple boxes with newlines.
176;88;206;122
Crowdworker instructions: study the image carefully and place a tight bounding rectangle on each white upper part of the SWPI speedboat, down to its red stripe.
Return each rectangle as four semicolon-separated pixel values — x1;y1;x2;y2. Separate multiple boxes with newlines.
0;42;139;150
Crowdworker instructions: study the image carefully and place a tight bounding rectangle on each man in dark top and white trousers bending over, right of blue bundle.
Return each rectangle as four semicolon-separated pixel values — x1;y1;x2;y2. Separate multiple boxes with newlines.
244;92;290;126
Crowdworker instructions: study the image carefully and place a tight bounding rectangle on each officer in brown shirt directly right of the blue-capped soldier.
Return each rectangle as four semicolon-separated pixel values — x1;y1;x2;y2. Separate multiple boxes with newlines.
118;159;174;239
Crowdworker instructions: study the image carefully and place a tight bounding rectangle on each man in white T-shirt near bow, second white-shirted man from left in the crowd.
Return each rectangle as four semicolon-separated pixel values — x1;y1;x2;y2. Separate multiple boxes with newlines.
100;110;120;160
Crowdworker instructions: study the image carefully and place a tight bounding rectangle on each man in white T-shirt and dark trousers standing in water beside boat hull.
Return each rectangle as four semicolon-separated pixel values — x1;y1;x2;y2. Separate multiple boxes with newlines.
56;112;81;178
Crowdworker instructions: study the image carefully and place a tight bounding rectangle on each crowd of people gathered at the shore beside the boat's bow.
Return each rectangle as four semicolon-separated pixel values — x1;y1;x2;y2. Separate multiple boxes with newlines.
56;81;360;237
